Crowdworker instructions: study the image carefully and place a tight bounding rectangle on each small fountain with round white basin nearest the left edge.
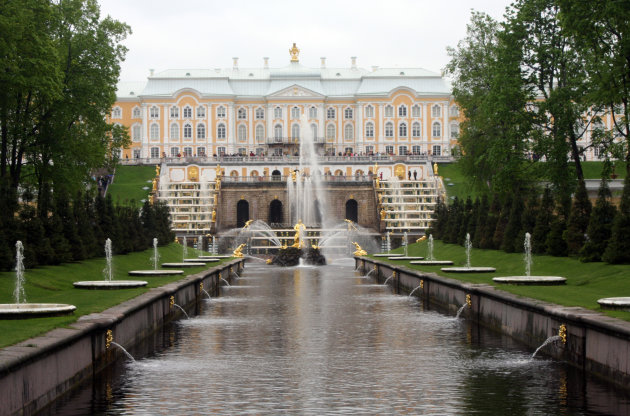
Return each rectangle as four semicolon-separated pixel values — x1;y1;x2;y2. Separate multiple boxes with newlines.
0;240;76;319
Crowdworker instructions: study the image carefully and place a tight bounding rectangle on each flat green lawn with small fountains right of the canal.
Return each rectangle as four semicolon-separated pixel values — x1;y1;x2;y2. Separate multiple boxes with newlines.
372;237;630;321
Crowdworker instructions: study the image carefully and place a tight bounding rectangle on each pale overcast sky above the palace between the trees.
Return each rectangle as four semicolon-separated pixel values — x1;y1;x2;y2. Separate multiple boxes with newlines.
100;0;510;81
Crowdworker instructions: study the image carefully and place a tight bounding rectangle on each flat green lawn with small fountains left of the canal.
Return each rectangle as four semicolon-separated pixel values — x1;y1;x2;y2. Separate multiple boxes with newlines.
0;243;229;348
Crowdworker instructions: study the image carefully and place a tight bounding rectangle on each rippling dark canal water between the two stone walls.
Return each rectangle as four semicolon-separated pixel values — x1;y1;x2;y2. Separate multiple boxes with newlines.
43;259;630;415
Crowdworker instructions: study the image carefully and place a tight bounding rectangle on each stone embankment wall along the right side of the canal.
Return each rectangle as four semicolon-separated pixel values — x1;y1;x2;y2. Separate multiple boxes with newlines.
356;258;630;389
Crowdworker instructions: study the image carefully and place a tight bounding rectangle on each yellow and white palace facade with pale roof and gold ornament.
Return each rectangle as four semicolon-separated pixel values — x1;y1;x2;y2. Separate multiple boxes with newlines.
110;48;460;159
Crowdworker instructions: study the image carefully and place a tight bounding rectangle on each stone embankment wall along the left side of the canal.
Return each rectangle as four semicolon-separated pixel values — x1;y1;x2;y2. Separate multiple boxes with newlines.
0;259;244;415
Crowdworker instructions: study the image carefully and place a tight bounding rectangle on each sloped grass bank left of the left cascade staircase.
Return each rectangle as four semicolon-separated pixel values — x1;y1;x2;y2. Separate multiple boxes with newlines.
107;165;155;206
